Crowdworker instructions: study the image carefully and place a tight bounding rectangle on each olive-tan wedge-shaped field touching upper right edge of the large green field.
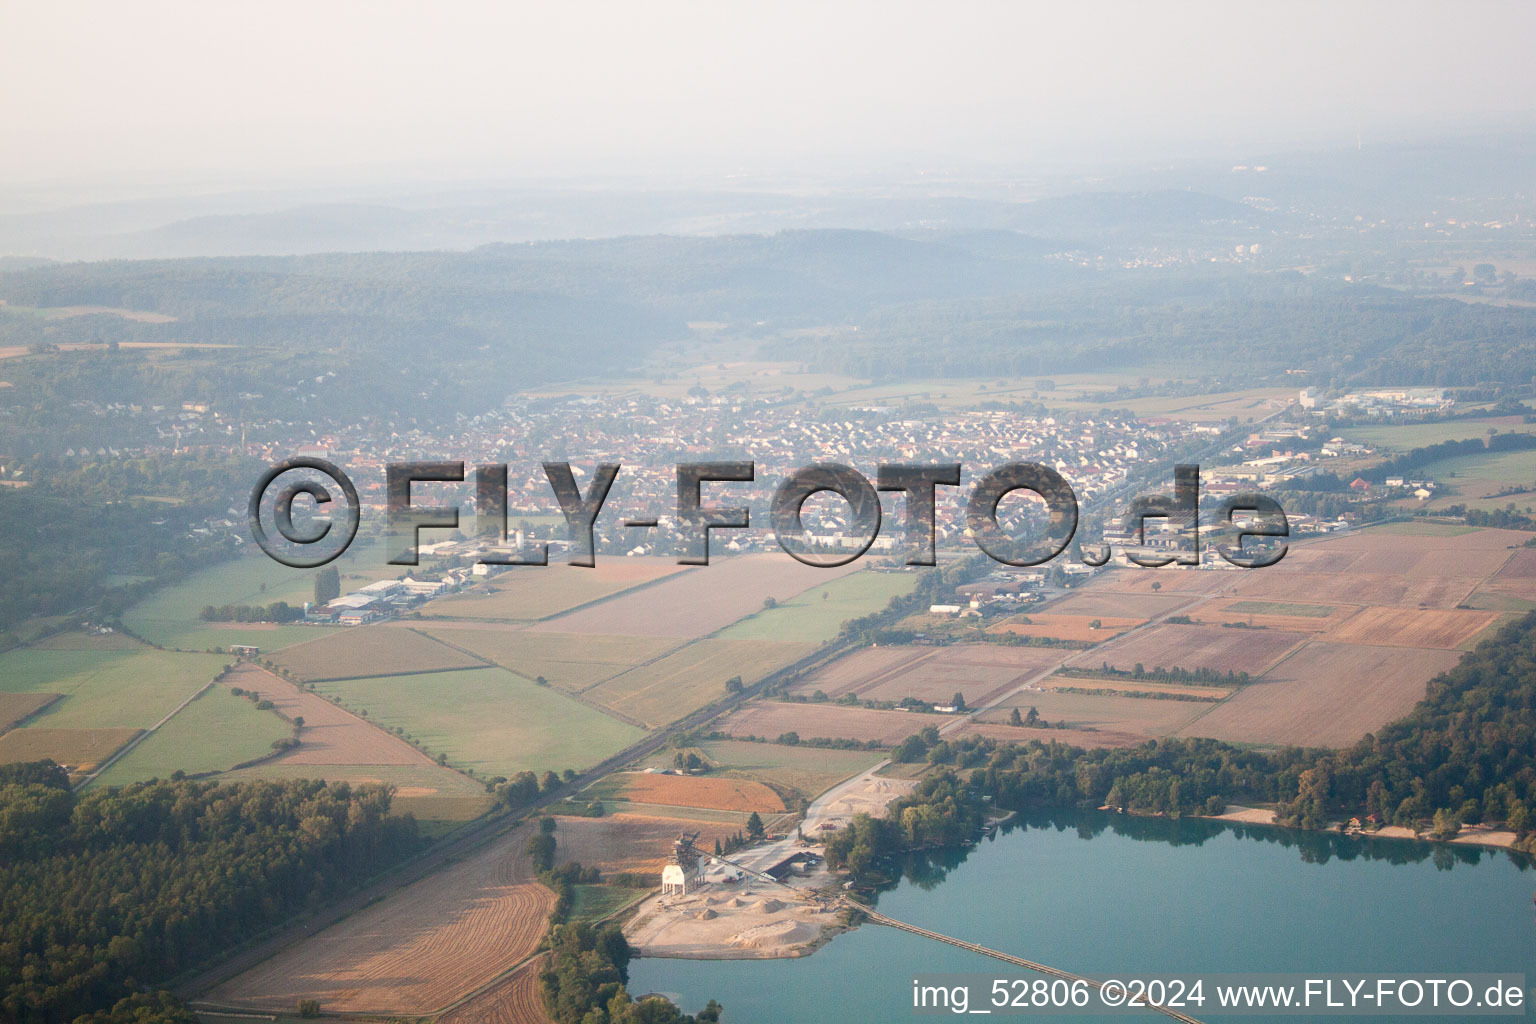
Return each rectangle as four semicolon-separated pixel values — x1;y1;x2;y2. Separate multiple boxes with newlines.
425;623;677;692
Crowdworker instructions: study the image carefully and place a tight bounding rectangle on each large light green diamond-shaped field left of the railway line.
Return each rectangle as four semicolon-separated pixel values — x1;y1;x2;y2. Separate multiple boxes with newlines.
315;668;644;775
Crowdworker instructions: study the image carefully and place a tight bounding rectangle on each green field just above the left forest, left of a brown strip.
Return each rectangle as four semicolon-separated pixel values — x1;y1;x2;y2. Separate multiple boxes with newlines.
92;686;293;786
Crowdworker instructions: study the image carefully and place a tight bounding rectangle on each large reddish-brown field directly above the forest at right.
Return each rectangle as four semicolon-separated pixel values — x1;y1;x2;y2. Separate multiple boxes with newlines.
1180;640;1461;746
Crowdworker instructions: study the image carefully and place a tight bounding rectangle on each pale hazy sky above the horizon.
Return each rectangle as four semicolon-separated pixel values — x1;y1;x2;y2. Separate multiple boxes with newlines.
0;0;1536;183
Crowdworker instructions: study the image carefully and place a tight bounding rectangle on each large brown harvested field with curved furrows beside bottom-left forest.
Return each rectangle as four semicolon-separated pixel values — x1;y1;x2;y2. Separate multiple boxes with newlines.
209;826;554;1015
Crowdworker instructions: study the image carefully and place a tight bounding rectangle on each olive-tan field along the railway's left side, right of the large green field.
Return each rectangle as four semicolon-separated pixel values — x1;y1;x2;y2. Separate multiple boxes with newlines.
582;639;813;728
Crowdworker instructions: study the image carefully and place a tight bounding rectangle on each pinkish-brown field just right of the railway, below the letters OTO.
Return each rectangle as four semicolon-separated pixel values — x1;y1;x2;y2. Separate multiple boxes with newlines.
794;643;1071;709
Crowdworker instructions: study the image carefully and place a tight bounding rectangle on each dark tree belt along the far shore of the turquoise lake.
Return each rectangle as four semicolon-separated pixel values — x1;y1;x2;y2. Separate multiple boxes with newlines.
826;613;1536;875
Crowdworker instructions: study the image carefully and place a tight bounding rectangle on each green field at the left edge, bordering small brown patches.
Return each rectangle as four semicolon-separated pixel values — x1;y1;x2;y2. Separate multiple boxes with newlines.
0;648;229;729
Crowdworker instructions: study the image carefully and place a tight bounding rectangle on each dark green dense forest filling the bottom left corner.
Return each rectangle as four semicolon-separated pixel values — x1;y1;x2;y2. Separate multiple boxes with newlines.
0;761;419;1024
